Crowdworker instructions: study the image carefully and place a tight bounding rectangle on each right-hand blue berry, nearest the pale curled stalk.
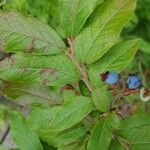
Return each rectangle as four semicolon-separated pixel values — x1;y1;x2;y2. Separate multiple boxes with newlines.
127;75;141;89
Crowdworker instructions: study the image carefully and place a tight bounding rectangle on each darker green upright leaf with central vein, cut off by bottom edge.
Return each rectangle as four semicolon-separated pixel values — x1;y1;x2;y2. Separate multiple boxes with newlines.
87;114;118;150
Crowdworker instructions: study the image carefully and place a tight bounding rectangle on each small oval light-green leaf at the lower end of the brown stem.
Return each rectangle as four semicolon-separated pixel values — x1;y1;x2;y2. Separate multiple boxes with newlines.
92;88;111;112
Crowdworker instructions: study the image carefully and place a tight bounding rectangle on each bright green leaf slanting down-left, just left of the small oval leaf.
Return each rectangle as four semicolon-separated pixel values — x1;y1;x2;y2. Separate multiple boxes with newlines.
41;96;94;132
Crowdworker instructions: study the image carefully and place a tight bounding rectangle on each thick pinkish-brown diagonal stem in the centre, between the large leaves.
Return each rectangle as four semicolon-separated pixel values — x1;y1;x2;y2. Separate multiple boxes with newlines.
67;39;93;92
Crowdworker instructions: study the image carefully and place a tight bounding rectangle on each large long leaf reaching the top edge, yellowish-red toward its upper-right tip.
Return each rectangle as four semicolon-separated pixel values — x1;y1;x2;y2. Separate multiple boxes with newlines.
75;0;136;64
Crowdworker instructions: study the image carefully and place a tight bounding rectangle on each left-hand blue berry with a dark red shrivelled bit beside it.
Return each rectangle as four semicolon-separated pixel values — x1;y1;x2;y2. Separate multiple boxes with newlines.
105;72;119;85
